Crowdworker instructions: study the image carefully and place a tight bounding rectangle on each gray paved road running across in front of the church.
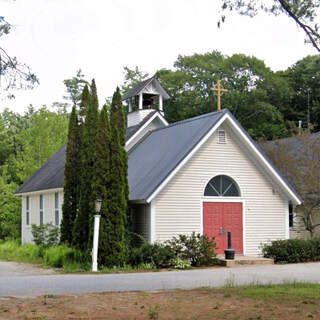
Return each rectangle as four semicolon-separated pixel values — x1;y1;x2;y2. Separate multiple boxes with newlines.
0;263;320;296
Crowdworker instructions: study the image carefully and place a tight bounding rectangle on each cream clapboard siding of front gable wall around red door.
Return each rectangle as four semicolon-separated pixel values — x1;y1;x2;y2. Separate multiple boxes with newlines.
155;125;288;255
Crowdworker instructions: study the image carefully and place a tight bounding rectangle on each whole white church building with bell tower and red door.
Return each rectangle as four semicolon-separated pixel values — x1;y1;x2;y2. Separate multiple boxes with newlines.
16;78;301;255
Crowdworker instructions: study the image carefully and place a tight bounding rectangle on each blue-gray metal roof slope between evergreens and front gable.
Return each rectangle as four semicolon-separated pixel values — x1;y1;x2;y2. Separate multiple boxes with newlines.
128;109;227;200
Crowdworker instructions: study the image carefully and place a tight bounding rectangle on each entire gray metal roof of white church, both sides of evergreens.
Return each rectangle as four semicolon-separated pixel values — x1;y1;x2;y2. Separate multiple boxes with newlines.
15;109;301;200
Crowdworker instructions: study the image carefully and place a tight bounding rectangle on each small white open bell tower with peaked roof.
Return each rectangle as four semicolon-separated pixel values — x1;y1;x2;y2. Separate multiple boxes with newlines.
122;77;170;127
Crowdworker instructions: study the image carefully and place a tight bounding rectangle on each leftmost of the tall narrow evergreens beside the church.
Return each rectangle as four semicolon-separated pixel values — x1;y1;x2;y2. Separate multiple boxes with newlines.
60;106;80;245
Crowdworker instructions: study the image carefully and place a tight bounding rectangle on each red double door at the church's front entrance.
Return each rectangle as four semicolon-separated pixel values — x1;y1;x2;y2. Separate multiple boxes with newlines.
203;202;243;254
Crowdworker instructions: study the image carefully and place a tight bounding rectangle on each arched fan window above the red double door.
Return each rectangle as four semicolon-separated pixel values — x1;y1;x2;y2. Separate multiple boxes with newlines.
204;175;240;197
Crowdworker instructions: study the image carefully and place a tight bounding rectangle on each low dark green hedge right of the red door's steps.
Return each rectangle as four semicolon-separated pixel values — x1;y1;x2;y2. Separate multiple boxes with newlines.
262;238;320;263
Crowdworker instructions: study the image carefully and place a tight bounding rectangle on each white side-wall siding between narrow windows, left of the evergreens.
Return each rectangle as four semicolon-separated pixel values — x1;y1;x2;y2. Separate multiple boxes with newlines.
21;190;63;244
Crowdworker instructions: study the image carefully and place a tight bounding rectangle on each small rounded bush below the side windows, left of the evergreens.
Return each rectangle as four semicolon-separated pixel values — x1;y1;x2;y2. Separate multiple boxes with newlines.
31;223;60;248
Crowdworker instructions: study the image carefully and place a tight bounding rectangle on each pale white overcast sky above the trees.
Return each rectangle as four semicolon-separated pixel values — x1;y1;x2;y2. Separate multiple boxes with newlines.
0;0;317;114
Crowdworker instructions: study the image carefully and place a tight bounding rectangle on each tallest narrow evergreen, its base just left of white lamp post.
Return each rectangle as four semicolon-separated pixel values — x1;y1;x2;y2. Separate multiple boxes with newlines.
72;80;99;250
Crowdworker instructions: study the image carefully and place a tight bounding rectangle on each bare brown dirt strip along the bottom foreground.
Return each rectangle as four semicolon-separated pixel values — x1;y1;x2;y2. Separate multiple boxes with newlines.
0;289;320;320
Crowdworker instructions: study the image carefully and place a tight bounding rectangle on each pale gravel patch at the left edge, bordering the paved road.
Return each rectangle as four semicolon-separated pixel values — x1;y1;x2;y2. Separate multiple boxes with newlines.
0;261;55;277
